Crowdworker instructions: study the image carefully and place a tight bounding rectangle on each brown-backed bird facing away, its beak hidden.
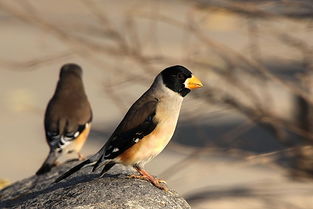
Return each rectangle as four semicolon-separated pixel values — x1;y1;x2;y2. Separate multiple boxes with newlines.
36;63;92;176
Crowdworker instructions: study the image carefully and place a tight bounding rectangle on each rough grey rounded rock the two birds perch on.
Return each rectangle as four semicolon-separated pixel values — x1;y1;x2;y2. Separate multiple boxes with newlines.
0;162;190;209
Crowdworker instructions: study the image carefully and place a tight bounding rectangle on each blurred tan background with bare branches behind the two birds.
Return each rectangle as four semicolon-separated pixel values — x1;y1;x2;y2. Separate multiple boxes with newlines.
0;0;313;209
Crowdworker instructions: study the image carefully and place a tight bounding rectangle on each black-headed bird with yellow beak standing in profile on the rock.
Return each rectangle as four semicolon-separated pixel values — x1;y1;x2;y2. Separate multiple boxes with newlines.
54;65;203;191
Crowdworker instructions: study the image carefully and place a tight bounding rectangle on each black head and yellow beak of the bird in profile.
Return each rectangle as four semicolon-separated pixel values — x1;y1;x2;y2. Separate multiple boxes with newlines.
161;65;202;97
